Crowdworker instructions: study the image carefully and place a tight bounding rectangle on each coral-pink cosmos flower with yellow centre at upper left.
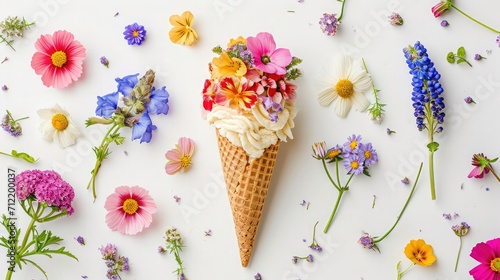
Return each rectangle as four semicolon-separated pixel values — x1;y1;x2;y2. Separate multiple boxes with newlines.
31;30;85;88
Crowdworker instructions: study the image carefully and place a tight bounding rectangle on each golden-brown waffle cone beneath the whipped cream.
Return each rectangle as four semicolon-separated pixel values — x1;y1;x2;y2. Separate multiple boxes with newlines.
217;131;280;267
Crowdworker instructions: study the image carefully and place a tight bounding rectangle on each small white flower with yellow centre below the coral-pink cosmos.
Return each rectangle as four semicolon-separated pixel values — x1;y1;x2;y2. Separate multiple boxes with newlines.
37;104;80;148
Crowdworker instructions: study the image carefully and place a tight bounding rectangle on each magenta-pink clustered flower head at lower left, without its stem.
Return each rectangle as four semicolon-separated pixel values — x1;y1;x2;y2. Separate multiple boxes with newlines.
15;169;75;215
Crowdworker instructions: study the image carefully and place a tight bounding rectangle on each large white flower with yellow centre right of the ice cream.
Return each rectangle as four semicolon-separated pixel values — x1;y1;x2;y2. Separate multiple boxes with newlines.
318;56;371;118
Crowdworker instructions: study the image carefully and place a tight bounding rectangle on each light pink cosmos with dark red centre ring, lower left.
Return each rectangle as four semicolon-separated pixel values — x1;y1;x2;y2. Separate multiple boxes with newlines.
104;186;157;235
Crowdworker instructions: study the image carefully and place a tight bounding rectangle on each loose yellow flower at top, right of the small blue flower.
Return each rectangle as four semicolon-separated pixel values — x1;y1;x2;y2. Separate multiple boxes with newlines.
168;11;198;46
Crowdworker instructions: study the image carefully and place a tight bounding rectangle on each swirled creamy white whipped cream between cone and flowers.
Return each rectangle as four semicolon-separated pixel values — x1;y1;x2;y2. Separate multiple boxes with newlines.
207;100;297;158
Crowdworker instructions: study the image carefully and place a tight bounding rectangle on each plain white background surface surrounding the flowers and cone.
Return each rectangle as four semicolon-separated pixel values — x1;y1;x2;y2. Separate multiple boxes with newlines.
0;0;500;280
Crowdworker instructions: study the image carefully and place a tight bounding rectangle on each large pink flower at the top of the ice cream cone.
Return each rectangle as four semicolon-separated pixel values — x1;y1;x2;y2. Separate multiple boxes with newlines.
247;32;292;75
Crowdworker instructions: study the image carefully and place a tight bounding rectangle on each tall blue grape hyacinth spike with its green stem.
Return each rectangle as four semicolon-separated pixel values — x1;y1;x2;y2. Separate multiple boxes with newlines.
403;41;445;200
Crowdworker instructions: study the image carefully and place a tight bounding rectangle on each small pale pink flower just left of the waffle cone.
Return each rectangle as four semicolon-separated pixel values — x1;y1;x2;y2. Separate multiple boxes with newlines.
165;137;194;175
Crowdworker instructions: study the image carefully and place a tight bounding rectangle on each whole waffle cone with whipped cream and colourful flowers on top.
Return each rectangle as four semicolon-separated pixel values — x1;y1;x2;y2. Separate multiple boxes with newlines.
203;32;301;267
